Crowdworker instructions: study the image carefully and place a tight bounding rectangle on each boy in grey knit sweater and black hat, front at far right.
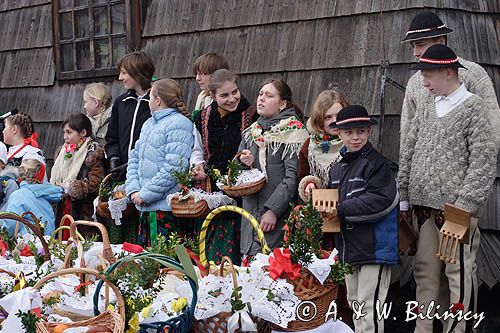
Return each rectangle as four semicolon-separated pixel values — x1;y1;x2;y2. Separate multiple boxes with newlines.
398;44;497;332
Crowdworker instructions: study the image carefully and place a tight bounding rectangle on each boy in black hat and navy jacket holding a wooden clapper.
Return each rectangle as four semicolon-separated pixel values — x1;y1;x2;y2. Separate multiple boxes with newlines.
329;105;399;333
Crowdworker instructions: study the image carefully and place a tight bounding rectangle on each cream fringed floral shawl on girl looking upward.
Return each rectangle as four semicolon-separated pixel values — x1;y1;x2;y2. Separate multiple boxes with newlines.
244;116;308;178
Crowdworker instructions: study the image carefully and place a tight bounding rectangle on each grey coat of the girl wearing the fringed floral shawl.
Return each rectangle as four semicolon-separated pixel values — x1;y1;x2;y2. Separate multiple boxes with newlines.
239;108;300;255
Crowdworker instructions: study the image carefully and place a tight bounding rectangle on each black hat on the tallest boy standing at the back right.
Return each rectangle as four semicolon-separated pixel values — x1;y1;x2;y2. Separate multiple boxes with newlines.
401;12;453;42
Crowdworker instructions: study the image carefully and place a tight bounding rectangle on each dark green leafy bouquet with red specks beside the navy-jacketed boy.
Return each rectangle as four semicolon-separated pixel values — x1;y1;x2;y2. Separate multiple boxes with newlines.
285;201;323;266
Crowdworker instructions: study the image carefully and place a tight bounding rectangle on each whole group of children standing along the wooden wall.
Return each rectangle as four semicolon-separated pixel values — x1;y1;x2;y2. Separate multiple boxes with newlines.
0;12;498;332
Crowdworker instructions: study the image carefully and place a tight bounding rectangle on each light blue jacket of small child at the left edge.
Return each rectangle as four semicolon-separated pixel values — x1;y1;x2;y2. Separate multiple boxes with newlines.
0;181;64;236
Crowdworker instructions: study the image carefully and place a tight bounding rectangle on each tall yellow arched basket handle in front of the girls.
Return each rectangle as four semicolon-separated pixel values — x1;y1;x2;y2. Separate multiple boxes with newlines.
198;206;271;266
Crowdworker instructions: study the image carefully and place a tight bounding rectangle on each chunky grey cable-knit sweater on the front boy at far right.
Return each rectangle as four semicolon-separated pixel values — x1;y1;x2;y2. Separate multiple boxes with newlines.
398;92;498;216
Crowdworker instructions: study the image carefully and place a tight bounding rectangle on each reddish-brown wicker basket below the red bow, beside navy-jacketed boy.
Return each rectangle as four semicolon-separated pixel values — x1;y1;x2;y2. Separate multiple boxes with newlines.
271;269;338;332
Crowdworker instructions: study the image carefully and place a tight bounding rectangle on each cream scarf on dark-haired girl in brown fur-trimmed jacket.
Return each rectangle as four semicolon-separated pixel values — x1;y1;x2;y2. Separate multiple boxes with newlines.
50;137;92;185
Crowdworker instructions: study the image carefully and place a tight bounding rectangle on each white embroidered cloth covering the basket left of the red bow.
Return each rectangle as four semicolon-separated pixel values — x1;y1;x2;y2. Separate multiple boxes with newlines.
194;264;299;327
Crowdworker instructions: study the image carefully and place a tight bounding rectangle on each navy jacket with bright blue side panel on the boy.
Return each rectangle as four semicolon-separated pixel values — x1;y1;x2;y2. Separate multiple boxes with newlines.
329;142;399;265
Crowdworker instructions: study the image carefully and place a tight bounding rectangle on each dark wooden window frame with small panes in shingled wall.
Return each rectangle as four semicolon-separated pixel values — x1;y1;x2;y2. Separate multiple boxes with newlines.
52;0;141;80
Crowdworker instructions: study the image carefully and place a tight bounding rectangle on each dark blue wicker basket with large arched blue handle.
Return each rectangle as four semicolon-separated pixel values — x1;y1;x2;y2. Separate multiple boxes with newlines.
94;252;198;333
